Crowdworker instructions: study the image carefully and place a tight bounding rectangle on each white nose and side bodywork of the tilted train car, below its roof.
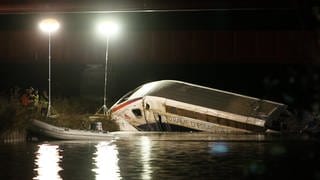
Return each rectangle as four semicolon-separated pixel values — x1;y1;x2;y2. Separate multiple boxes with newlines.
112;96;265;133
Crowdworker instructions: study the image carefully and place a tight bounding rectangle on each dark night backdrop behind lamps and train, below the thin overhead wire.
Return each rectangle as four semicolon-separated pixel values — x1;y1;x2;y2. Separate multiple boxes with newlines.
0;0;320;114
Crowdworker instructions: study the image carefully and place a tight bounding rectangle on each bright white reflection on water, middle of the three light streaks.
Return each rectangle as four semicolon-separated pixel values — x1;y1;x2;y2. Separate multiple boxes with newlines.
92;142;121;180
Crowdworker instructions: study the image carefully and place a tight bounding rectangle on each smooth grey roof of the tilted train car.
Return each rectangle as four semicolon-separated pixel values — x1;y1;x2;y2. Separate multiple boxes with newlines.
129;80;286;118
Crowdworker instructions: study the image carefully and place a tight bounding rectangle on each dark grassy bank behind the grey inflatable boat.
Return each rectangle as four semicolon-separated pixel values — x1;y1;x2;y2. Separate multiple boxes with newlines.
0;97;119;140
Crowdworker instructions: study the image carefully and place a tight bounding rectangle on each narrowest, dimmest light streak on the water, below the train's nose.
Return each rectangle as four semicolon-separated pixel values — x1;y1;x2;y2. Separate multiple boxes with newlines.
141;136;152;180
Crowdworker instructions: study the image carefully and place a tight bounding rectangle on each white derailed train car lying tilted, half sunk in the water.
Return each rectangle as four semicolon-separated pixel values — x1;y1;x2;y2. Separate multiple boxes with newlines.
110;80;287;133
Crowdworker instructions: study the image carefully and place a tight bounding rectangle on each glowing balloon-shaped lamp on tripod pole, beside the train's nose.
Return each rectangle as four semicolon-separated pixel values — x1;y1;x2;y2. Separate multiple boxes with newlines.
96;21;119;116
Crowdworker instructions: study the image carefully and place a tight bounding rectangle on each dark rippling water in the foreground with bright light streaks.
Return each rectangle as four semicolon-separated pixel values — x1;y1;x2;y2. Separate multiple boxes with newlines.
0;133;320;180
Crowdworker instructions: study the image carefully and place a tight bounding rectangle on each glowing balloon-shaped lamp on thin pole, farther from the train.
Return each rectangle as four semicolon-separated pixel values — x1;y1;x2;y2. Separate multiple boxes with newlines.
39;18;60;117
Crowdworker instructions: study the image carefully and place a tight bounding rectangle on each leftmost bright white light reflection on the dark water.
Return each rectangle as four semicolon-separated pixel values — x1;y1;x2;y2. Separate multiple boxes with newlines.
33;144;62;180
